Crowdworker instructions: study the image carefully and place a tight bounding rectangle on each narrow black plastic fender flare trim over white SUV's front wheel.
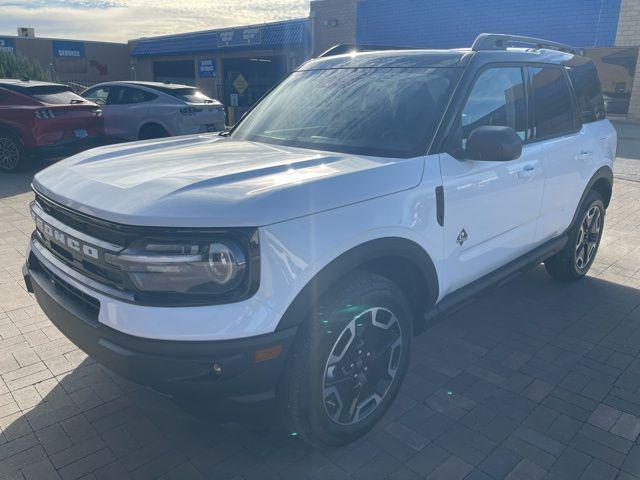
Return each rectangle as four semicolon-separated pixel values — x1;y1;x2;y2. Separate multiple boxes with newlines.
276;237;439;331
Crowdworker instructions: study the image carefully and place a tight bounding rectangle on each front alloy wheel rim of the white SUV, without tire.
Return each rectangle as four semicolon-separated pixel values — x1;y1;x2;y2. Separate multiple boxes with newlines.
322;307;403;425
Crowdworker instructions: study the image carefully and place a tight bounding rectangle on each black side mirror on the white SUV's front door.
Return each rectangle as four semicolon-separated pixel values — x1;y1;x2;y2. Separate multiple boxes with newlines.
465;125;522;162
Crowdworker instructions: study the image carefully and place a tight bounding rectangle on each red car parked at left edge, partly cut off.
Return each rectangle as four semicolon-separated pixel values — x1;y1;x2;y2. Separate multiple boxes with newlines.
0;79;104;172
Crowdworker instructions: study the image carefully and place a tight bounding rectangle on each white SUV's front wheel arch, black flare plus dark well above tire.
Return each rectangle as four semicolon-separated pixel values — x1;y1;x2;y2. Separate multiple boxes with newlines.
276;237;439;331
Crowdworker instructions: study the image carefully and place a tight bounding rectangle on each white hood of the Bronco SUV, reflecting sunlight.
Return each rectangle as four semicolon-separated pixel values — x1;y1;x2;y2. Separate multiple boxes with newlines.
33;135;424;227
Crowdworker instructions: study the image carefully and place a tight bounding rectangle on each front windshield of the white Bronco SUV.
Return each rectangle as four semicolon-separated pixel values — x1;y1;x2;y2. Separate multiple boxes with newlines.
232;68;459;157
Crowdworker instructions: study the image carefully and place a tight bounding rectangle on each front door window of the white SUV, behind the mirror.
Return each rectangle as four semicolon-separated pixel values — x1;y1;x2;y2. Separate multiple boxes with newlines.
461;67;527;143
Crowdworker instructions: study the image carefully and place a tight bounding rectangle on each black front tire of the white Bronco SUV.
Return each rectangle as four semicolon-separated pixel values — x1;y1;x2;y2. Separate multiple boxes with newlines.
279;272;413;447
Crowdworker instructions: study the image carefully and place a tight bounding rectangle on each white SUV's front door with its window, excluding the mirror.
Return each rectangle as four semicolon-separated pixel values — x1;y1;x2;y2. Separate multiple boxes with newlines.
440;66;544;294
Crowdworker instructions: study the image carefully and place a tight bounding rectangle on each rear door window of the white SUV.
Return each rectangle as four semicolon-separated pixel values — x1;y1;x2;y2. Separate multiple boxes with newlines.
531;67;574;138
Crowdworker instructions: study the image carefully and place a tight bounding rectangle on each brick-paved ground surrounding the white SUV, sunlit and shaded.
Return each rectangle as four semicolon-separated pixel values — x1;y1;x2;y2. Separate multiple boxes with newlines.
0;124;640;480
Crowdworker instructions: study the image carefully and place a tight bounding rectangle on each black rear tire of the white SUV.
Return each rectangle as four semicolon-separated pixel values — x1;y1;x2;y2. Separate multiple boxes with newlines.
544;190;605;282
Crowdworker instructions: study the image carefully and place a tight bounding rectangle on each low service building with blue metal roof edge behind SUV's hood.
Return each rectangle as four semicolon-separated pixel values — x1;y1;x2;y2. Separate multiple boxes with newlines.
129;18;311;123
